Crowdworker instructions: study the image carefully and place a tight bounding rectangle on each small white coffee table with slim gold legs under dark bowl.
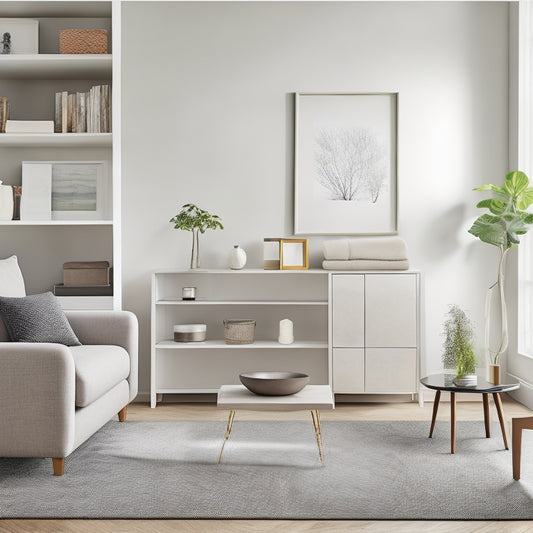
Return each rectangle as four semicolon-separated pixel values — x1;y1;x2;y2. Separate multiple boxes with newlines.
217;385;335;466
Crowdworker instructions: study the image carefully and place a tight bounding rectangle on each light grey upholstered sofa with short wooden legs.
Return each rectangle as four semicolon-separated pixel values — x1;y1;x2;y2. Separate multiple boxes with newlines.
0;311;138;475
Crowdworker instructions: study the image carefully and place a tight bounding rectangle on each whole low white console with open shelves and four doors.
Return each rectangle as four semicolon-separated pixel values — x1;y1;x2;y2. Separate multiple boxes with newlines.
151;269;420;407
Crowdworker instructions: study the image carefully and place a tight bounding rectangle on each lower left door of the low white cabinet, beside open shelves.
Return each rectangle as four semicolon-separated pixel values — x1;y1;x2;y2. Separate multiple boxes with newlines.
333;348;365;394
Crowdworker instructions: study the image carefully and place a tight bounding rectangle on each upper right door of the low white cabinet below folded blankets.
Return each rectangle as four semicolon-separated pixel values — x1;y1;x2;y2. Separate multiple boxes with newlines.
365;274;417;348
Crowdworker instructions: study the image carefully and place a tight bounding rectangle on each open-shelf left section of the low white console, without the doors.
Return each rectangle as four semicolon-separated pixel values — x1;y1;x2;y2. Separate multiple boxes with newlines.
151;270;331;407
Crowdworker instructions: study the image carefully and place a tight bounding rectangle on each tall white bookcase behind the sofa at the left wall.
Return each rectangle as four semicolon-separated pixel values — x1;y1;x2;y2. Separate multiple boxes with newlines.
0;0;121;309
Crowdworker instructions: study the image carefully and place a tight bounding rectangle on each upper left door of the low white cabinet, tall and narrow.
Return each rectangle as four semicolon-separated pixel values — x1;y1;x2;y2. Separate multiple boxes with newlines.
332;274;365;348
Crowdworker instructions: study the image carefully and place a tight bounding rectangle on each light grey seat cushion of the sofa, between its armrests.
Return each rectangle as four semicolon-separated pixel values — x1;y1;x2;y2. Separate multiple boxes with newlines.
70;344;130;407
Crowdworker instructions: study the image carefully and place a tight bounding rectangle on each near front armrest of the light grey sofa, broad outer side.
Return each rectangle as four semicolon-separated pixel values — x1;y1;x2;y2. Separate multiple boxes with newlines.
0;342;76;457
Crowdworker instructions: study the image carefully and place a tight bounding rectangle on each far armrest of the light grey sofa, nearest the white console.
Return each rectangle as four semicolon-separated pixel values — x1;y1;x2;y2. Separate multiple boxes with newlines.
65;311;139;401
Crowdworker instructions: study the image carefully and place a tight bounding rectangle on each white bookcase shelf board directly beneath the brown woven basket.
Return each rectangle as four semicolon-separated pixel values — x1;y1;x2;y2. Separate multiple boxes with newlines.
0;54;113;80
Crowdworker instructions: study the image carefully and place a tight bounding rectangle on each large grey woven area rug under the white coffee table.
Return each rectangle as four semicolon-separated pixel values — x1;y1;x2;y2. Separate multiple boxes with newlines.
0;420;533;520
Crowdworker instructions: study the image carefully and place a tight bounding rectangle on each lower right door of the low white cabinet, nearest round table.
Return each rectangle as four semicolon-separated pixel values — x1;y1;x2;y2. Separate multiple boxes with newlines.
365;348;417;393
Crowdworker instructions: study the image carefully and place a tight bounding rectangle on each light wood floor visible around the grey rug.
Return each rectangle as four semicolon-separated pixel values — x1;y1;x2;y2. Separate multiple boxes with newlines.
0;396;533;533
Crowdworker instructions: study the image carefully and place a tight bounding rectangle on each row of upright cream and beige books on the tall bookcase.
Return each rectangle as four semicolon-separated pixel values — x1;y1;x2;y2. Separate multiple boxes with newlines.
54;85;111;133
